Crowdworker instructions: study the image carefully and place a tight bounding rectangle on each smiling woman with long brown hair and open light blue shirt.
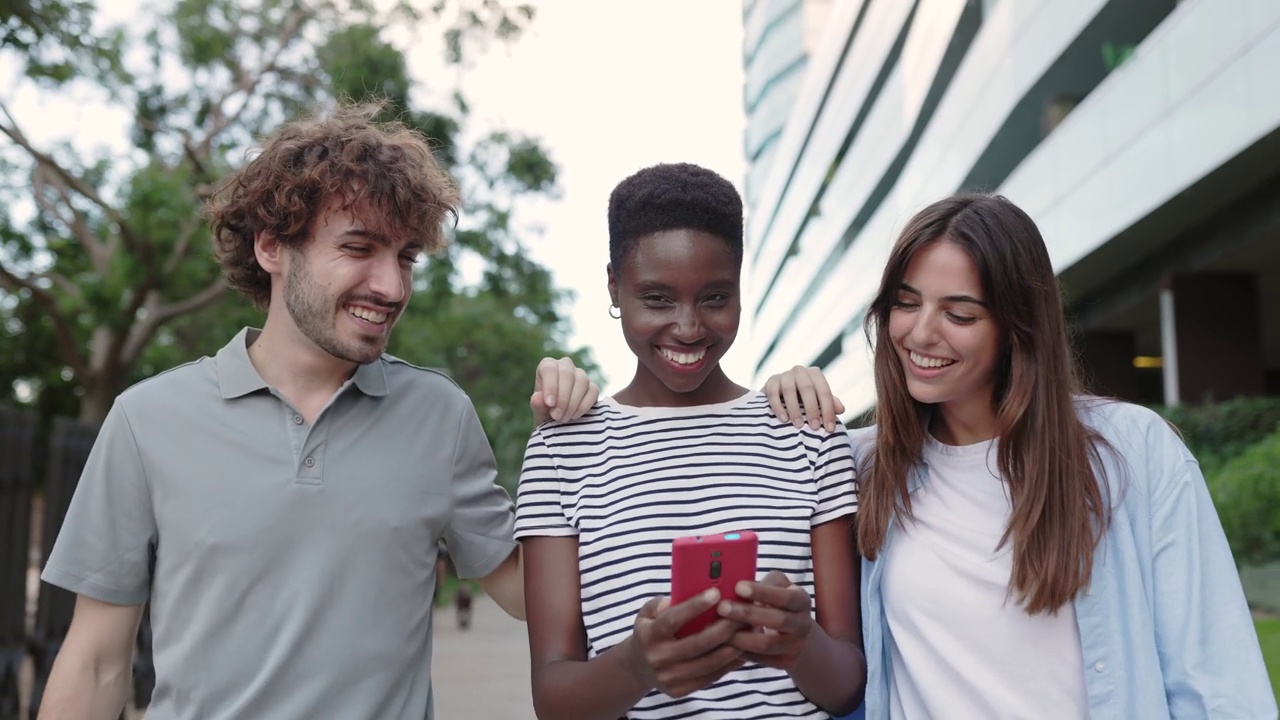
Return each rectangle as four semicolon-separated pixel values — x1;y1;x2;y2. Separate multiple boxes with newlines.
765;195;1276;719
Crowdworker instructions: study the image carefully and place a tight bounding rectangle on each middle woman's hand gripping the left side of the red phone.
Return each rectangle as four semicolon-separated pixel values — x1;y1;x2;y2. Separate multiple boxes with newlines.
631;589;745;697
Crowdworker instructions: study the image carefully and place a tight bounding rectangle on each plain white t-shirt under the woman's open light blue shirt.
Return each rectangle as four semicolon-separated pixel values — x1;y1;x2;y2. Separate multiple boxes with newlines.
883;437;1088;720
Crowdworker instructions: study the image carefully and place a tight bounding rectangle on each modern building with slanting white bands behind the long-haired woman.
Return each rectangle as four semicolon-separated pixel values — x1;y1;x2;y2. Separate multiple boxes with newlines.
745;0;1280;414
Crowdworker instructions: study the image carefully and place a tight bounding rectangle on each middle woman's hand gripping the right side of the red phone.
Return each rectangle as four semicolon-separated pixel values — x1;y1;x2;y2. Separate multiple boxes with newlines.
717;570;814;670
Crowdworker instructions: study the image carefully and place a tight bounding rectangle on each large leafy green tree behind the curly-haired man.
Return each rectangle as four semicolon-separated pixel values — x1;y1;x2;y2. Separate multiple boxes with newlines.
0;0;591;481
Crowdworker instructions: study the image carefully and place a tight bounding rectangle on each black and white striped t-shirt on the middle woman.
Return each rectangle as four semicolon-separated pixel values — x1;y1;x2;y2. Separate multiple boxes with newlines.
516;392;858;720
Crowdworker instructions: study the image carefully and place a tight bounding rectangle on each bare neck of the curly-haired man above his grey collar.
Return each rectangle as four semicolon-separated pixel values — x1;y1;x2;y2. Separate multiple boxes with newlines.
248;311;356;402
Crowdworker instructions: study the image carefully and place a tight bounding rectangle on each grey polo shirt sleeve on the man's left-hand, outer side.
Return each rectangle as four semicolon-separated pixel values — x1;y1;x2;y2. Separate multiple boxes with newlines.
41;400;157;605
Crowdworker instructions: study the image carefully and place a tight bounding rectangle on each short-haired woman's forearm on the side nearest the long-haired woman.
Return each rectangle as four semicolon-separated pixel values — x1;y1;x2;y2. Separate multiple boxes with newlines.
790;624;867;715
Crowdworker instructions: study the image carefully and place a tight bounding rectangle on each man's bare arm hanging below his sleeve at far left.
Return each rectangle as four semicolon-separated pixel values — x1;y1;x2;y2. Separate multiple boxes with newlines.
40;596;142;720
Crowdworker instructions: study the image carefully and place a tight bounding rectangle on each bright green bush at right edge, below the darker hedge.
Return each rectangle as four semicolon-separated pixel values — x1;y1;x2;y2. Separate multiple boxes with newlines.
1206;432;1280;564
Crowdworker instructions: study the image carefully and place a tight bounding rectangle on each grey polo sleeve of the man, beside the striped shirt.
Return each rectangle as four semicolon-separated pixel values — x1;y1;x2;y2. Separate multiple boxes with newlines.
444;401;516;578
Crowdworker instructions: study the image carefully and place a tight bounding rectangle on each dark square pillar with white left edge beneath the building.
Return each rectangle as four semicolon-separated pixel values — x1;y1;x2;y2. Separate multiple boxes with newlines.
1161;273;1266;404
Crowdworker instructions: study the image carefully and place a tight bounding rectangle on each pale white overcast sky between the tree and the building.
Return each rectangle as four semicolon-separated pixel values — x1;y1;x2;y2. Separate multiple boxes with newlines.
0;0;751;392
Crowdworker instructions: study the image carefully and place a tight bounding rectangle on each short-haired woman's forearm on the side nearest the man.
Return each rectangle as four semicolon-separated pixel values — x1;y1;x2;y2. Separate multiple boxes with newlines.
534;637;653;720
